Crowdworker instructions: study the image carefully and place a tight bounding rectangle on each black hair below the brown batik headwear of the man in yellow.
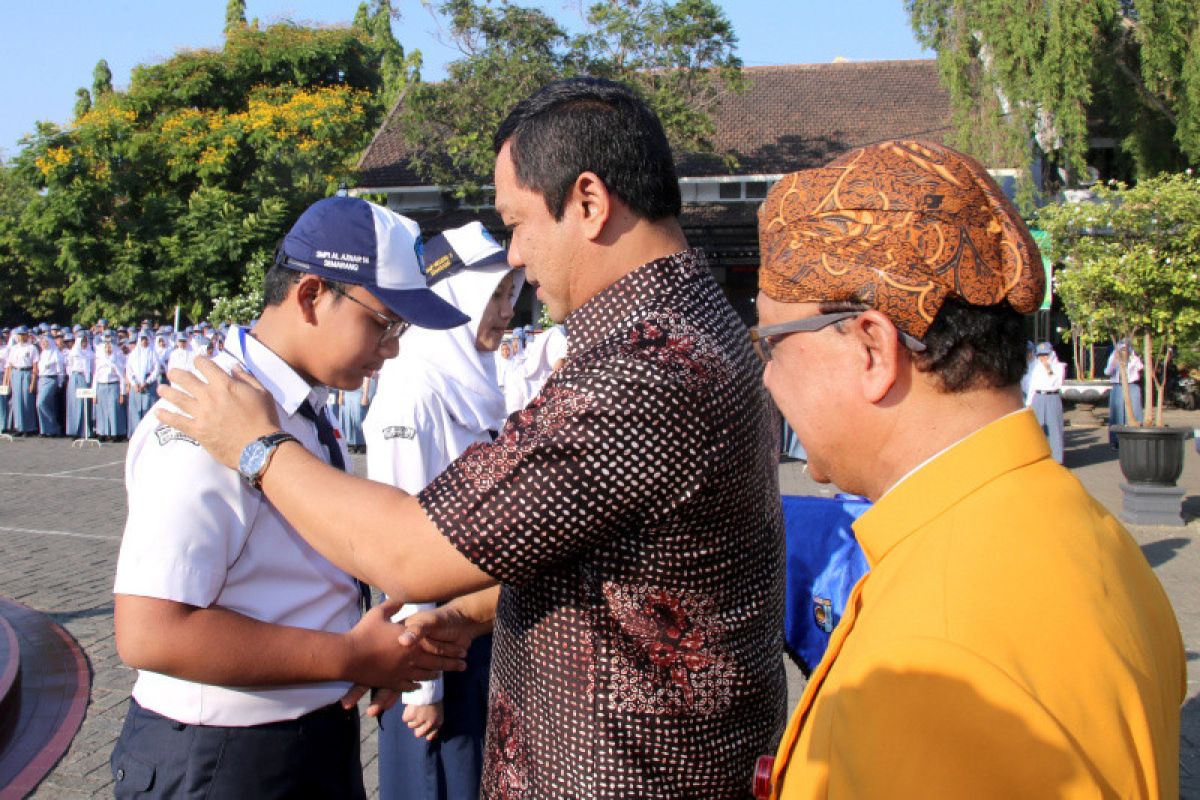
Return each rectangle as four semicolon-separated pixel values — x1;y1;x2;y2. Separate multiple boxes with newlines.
821;297;1026;393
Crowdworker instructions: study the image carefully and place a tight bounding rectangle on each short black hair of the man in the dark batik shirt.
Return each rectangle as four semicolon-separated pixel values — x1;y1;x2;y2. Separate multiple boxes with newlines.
492;78;683;222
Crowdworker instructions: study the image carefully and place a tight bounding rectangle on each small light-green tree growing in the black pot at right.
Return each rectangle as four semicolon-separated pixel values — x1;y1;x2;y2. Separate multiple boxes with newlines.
1038;170;1200;426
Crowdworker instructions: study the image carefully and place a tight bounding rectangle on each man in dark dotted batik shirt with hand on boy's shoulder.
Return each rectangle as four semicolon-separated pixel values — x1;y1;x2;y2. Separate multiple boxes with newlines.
169;79;786;799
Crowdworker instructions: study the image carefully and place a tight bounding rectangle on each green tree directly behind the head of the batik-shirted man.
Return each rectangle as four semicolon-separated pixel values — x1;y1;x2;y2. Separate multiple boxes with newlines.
398;0;742;197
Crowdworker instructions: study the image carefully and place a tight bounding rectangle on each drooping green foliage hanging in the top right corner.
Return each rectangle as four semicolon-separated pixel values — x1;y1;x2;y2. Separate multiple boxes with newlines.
905;0;1200;191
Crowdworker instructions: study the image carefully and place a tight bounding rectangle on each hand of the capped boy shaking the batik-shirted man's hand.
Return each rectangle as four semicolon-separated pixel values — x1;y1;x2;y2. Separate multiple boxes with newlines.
346;601;467;692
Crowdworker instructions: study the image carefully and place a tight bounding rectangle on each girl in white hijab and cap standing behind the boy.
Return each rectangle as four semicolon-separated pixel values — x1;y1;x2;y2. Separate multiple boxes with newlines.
364;222;522;800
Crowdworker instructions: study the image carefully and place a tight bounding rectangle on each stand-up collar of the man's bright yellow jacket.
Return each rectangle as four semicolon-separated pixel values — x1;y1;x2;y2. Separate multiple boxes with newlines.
854;409;1050;567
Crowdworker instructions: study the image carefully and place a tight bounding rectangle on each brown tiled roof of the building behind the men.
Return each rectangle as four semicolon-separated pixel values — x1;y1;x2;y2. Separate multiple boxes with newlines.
356;60;950;188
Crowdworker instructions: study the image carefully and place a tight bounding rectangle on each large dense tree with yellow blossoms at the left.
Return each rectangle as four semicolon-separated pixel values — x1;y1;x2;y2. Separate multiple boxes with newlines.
0;19;383;323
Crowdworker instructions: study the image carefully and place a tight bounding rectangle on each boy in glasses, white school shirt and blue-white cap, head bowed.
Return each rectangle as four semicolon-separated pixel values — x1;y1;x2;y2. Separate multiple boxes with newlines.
110;197;466;798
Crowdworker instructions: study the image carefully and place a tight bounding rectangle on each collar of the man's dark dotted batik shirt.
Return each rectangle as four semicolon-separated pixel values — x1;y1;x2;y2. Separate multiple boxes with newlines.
563;247;708;353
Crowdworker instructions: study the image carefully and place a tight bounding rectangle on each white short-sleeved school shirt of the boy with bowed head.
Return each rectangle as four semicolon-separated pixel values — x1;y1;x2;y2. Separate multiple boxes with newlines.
114;329;360;727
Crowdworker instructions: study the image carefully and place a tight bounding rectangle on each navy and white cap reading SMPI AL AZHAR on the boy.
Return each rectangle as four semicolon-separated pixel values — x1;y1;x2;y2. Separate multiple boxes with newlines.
275;197;469;330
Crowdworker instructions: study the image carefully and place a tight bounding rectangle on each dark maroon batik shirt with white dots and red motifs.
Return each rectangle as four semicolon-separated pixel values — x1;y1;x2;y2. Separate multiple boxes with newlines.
420;251;786;800
